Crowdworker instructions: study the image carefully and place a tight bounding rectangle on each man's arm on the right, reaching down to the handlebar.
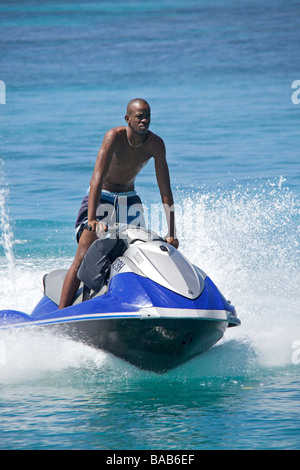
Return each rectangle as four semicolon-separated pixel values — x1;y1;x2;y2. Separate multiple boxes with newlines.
154;139;179;248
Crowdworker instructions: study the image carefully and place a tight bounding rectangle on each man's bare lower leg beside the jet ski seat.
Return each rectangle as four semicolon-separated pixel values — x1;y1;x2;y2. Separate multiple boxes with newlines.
59;230;97;309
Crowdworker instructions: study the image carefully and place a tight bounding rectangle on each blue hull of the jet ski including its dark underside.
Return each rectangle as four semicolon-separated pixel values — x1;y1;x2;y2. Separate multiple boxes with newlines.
0;273;240;373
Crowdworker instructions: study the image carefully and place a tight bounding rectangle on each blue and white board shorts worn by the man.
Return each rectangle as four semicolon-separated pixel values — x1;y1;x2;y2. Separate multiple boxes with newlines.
75;189;145;243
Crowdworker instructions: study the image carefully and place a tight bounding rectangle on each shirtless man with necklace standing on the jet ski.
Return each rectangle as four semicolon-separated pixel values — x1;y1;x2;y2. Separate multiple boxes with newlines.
59;99;178;308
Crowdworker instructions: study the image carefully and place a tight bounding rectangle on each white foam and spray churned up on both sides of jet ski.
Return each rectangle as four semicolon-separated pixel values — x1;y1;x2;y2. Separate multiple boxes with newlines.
0;179;300;382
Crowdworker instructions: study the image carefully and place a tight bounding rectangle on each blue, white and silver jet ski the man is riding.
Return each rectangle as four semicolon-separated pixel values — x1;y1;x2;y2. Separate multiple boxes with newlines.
0;225;240;373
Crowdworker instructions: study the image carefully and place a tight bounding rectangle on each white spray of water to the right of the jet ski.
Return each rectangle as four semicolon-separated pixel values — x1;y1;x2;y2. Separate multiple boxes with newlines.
176;178;300;371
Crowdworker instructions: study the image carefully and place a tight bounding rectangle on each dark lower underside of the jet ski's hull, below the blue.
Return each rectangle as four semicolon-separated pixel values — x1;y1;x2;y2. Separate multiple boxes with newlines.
55;318;228;373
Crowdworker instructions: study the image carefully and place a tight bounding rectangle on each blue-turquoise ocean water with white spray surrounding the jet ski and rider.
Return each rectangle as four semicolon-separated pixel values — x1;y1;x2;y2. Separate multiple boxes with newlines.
0;0;300;451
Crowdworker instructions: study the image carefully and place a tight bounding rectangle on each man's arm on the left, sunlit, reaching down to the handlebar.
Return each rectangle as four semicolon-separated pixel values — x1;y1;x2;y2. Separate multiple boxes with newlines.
88;129;117;231
